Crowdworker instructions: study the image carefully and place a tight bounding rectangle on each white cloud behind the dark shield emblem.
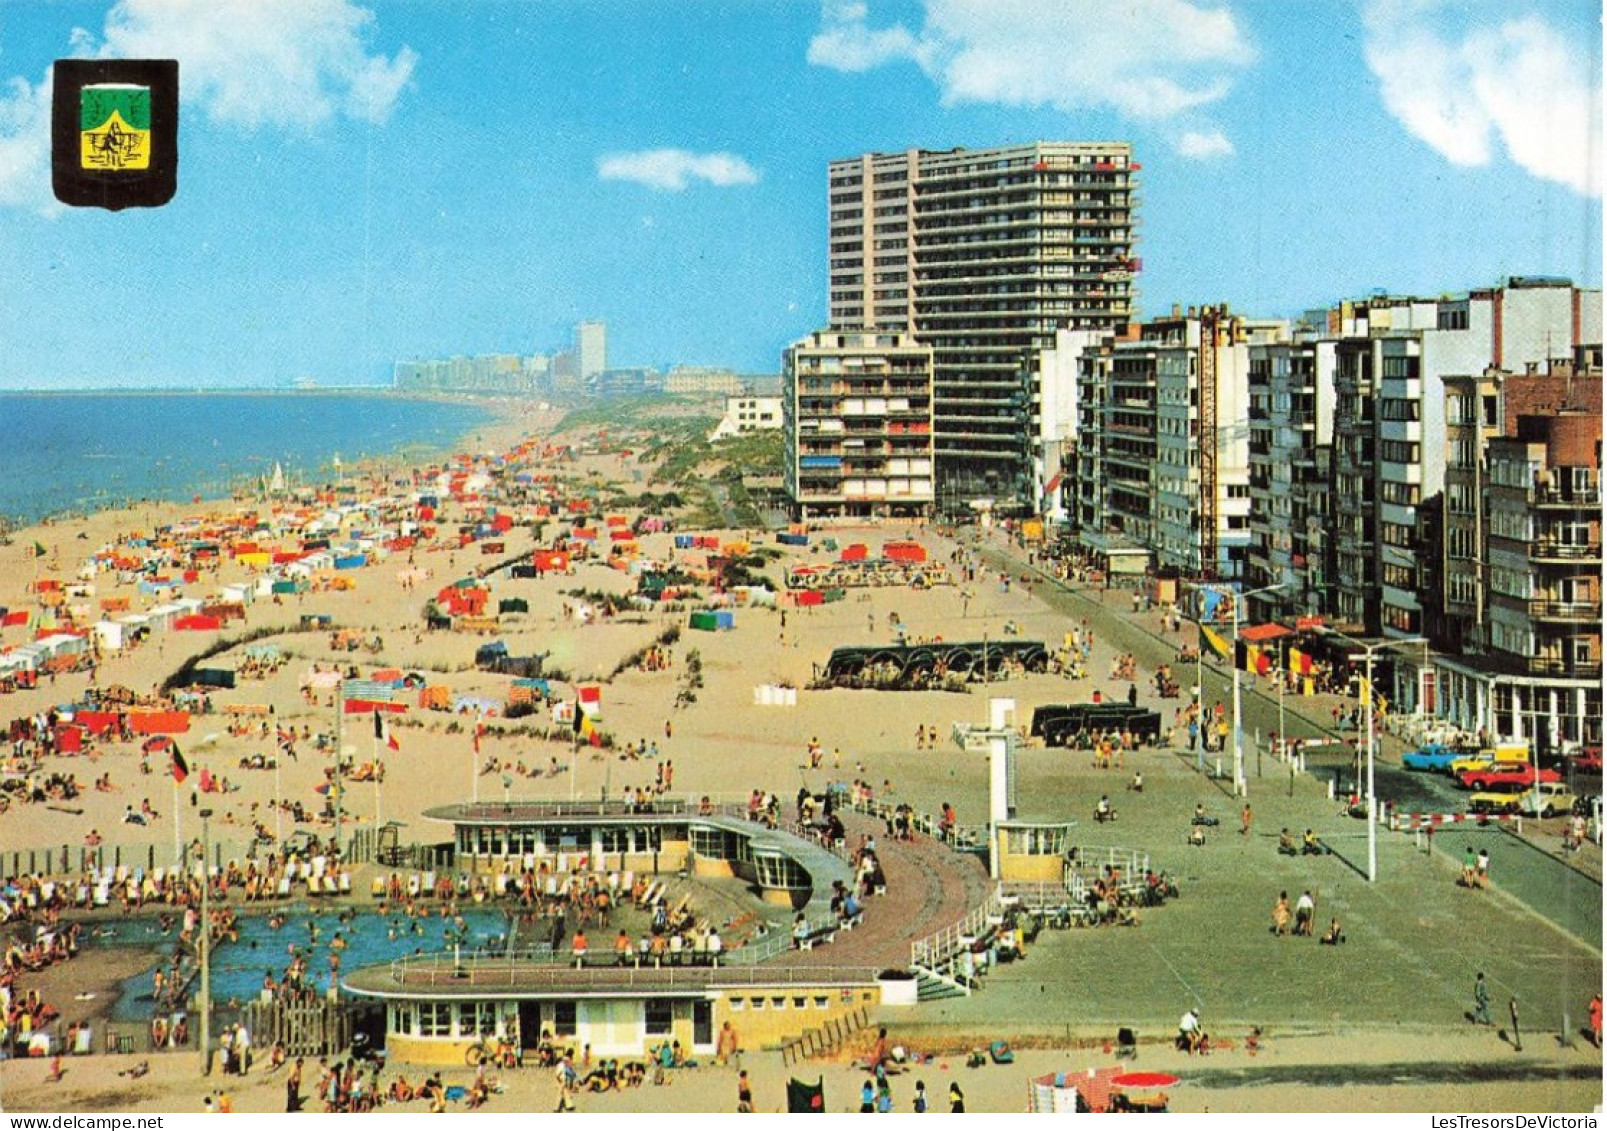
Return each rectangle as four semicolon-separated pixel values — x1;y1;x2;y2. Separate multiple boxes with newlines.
0;0;418;215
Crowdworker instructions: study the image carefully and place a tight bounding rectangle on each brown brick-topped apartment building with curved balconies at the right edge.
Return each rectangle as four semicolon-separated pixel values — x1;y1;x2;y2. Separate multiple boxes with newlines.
1422;363;1602;749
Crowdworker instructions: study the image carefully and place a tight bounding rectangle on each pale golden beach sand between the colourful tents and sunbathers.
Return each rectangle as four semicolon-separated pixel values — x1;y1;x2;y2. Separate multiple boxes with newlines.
0;398;1602;1112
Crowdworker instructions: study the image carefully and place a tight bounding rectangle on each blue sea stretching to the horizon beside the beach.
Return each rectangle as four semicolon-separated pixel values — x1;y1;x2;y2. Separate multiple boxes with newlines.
0;390;493;525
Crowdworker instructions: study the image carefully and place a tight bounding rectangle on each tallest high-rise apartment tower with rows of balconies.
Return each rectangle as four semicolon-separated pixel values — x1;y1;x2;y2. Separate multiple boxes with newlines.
828;141;1139;512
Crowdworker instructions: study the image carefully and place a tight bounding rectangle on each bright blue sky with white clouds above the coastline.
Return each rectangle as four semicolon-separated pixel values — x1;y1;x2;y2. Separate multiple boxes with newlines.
0;0;1602;389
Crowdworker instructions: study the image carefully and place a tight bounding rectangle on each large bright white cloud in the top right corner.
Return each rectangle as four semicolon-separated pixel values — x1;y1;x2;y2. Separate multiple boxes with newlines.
1364;0;1602;196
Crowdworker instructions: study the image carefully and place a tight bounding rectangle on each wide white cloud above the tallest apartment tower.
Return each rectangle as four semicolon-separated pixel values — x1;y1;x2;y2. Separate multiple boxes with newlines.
808;0;1255;120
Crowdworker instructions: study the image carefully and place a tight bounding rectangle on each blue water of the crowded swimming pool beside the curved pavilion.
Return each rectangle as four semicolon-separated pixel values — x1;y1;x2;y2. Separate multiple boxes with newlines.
92;908;534;1022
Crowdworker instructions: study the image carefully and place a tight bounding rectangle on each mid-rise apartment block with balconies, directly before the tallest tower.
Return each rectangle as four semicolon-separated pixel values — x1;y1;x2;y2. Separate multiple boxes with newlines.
781;329;934;519
